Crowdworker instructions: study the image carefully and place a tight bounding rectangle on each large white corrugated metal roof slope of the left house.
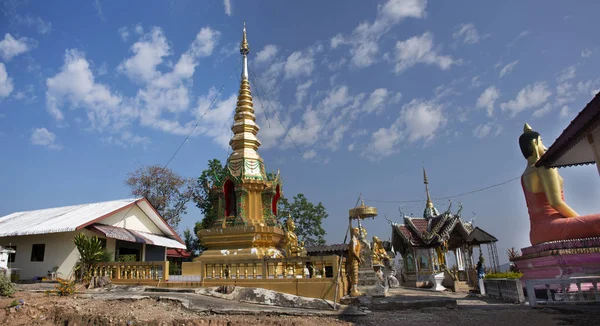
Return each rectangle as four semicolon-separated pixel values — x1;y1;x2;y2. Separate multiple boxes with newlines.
0;198;140;237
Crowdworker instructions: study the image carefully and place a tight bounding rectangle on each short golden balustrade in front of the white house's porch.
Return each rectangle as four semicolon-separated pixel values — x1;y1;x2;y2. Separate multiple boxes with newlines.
92;261;169;281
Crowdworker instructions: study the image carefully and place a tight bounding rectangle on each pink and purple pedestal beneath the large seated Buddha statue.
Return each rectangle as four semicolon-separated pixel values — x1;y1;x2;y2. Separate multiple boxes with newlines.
512;238;600;286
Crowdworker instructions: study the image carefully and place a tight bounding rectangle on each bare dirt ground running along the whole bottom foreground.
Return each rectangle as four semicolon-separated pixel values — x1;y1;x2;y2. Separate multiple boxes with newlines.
0;292;598;326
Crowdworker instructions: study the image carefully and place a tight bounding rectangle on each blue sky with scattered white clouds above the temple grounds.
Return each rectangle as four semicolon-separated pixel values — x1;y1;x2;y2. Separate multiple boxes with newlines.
0;0;600;262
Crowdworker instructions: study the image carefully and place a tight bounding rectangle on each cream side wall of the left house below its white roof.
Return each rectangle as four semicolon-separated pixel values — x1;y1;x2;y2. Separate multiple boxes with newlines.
0;232;79;279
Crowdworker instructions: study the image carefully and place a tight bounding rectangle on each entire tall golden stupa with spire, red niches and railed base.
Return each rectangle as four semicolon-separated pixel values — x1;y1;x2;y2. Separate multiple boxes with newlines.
182;25;345;300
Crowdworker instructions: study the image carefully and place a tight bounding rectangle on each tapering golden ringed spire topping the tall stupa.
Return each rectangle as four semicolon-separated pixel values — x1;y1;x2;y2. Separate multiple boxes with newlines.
228;23;262;161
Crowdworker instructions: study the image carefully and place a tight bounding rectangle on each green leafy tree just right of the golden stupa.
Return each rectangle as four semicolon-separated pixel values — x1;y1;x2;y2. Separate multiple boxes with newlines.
277;194;329;245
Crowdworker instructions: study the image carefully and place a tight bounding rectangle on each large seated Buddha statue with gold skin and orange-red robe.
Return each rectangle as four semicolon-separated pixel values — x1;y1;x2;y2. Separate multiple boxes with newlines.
519;124;600;245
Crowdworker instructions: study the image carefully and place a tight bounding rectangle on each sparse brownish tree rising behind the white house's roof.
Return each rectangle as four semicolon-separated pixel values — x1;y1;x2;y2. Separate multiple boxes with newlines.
125;165;195;229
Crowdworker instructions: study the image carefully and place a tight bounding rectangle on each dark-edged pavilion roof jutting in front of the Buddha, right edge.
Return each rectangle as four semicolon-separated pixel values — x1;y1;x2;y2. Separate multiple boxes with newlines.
536;93;600;168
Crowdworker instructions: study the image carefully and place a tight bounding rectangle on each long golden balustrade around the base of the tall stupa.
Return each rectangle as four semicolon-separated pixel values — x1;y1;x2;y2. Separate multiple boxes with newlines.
202;256;345;280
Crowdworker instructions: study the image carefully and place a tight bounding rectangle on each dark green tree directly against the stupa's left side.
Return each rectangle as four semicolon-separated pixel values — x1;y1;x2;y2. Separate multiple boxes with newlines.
194;159;227;230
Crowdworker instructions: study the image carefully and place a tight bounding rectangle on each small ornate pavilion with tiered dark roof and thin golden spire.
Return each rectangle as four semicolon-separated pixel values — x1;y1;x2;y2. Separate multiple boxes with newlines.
391;169;499;288
